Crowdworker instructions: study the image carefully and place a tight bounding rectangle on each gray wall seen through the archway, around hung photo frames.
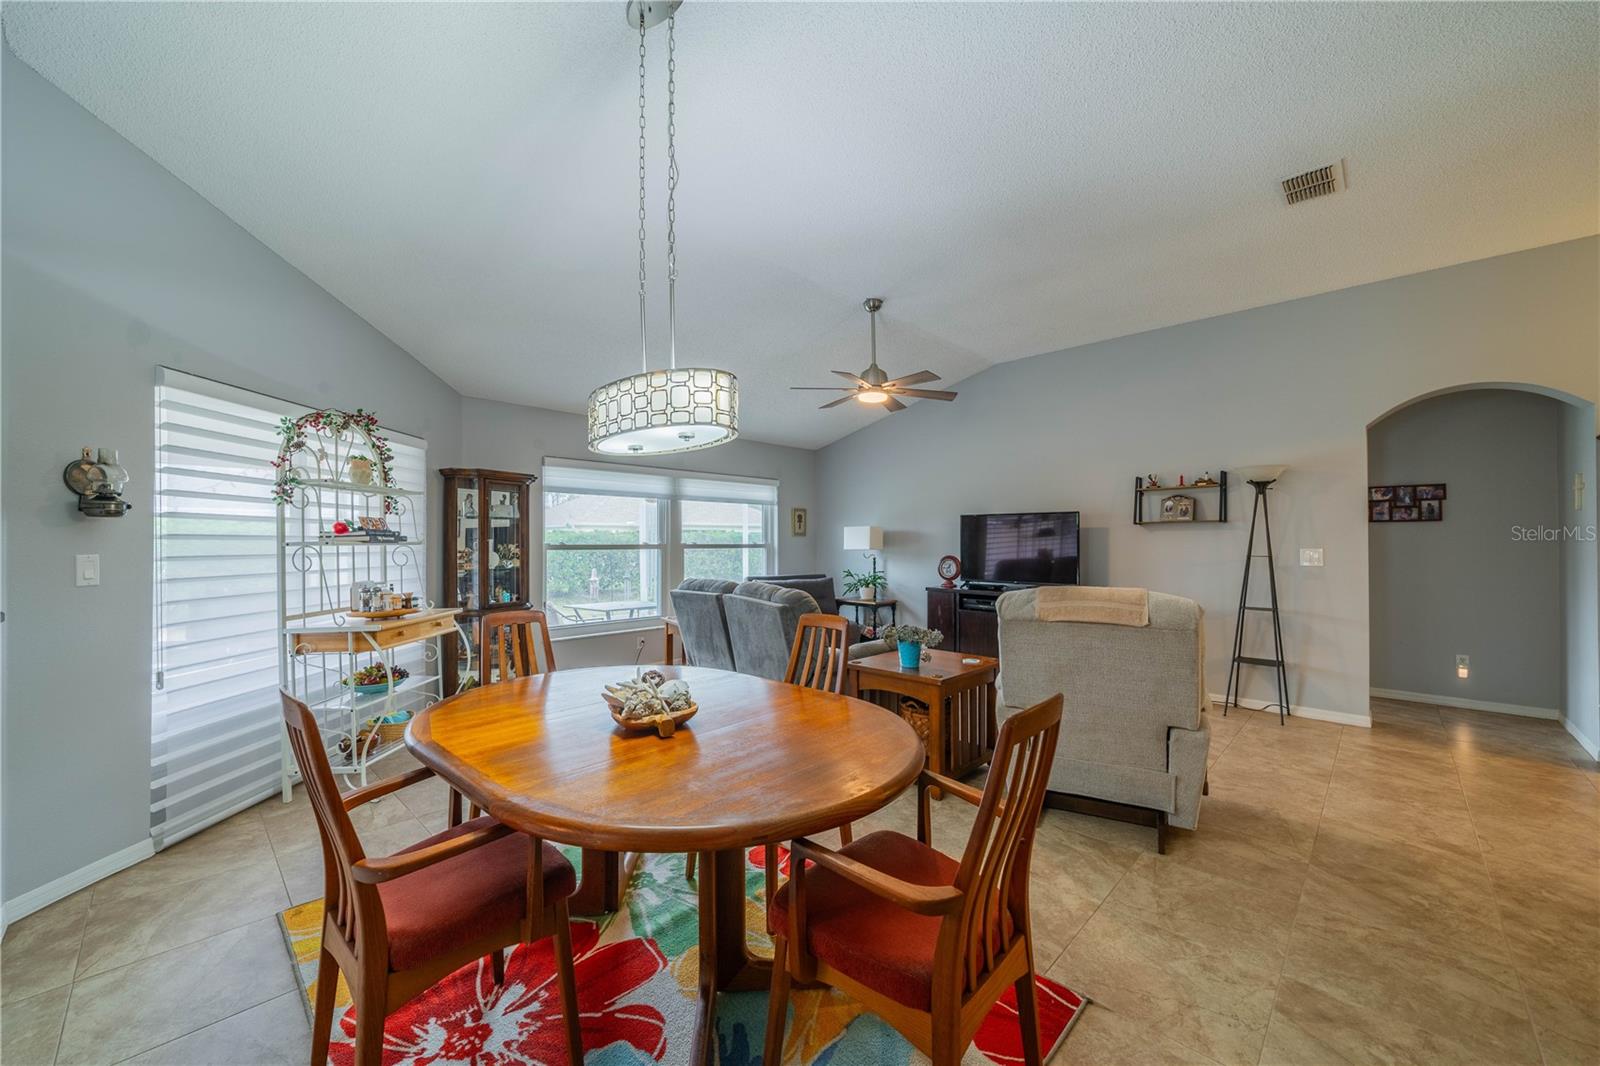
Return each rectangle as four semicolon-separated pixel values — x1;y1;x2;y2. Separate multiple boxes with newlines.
1366;389;1578;704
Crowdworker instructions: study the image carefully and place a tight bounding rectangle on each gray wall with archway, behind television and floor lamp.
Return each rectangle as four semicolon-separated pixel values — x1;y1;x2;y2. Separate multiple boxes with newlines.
813;238;1600;719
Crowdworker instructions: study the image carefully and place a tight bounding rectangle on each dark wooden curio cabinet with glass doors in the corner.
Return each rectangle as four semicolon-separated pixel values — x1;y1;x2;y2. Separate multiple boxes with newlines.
440;467;539;677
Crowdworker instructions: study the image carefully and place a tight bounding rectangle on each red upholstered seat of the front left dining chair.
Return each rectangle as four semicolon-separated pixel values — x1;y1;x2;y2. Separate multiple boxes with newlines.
378;818;578;970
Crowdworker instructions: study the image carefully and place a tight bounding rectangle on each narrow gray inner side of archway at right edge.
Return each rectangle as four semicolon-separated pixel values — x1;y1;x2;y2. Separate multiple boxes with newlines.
1557;405;1600;745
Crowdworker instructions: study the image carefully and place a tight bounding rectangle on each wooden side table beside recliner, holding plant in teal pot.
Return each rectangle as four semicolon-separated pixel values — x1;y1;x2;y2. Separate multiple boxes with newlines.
845;650;1000;793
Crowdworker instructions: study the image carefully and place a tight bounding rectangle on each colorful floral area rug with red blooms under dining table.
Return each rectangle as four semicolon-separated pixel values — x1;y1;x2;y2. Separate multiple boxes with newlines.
280;848;1086;1066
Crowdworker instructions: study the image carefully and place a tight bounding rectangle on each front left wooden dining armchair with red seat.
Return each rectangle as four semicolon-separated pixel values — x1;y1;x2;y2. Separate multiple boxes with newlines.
280;691;582;1066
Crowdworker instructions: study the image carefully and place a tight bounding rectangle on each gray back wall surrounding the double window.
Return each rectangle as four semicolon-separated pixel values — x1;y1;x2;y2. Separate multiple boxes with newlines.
461;399;816;666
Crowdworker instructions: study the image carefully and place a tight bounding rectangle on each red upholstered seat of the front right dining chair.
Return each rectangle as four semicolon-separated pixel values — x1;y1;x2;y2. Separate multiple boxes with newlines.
771;831;960;1010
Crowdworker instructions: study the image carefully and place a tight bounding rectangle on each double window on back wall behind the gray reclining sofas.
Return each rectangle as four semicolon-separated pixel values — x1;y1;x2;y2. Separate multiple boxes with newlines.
542;459;778;631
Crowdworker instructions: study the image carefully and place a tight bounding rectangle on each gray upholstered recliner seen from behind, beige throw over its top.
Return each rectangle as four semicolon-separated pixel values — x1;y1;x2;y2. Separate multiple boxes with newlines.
997;589;1211;850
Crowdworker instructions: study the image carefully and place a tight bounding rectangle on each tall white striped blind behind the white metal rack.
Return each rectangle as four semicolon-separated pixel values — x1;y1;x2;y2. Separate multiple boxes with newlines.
150;368;427;847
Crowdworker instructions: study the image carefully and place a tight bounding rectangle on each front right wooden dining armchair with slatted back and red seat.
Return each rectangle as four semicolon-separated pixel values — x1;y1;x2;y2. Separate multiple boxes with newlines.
763;695;1061;1066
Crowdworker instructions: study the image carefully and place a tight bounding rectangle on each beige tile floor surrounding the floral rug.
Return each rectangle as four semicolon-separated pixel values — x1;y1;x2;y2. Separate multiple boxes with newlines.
0;701;1600;1066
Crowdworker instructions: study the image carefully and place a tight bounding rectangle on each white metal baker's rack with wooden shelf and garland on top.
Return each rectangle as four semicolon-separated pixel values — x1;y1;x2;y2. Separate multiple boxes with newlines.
277;416;470;802
